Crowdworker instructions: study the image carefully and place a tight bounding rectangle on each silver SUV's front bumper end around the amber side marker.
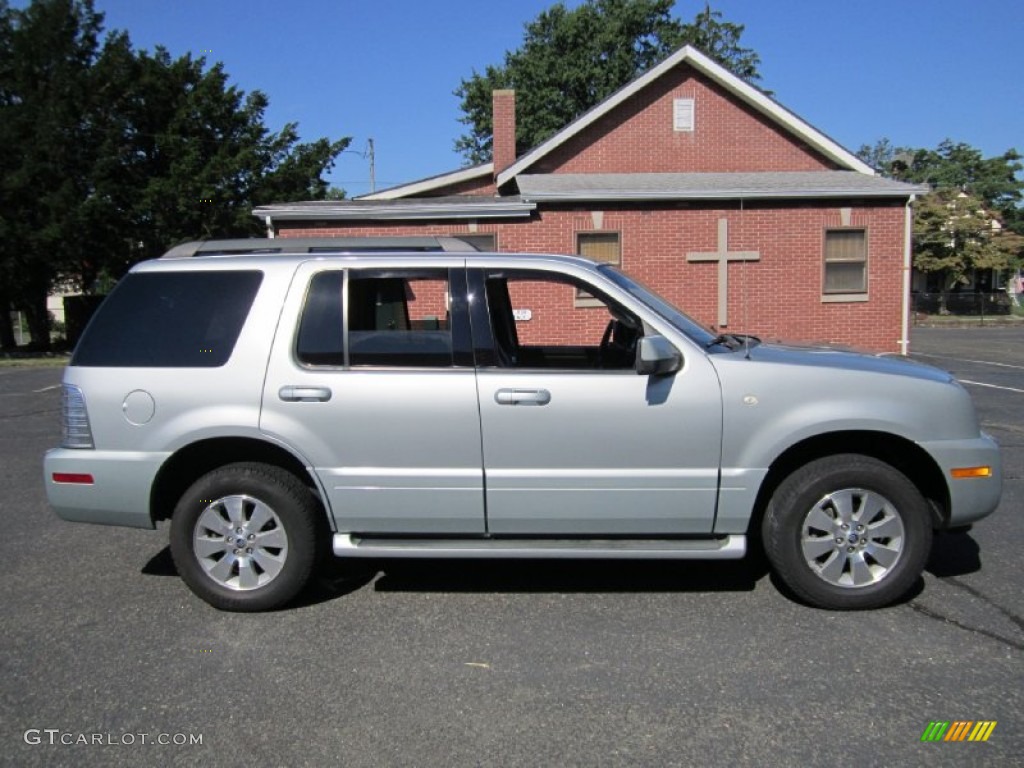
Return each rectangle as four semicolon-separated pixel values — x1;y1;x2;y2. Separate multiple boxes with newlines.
922;432;1002;527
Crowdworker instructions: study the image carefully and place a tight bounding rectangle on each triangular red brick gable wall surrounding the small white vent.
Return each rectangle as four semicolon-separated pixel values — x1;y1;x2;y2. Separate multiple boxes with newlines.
525;65;838;173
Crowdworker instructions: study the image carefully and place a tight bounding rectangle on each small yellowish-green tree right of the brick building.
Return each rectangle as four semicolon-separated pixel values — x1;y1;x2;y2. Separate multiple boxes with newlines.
913;187;1024;313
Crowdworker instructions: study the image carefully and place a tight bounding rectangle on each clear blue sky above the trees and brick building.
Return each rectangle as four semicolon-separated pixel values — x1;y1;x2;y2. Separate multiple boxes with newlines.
32;0;1024;197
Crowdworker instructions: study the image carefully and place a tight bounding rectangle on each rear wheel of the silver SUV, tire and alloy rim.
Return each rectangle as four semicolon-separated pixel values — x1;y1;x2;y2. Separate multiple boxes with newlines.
171;463;322;611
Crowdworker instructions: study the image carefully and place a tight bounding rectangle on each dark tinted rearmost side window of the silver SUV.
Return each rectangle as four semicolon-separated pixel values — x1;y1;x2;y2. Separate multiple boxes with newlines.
71;270;263;368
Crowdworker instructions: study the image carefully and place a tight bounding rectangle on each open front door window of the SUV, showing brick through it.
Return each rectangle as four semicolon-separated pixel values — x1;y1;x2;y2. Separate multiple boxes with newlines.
485;271;643;371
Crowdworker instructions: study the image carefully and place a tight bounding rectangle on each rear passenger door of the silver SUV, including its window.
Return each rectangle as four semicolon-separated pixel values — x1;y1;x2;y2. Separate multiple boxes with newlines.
260;259;484;534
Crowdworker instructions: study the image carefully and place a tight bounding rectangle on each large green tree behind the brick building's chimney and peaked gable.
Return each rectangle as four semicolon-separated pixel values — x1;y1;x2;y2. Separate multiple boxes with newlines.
455;0;761;163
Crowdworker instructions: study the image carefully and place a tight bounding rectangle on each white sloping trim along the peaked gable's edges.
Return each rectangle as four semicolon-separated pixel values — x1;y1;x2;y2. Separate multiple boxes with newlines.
497;45;874;187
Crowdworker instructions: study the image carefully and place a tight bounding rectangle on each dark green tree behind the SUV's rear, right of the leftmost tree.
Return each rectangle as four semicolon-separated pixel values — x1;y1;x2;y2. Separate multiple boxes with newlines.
82;35;349;276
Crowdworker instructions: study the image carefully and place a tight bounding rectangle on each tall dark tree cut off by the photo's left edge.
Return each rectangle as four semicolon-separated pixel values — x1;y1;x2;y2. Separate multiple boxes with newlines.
0;0;101;347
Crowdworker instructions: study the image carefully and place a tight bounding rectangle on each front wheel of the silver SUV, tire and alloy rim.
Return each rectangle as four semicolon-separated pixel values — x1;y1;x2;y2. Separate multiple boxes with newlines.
762;454;932;610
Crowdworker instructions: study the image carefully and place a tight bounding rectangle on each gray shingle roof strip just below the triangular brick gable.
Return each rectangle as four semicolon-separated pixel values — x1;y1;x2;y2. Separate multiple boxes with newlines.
516;171;929;203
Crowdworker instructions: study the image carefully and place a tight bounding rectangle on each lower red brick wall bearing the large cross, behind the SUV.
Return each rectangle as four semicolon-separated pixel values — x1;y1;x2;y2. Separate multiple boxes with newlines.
280;199;904;352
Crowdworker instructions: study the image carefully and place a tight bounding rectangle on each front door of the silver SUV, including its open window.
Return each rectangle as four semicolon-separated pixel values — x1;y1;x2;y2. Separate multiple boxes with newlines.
470;268;722;537
